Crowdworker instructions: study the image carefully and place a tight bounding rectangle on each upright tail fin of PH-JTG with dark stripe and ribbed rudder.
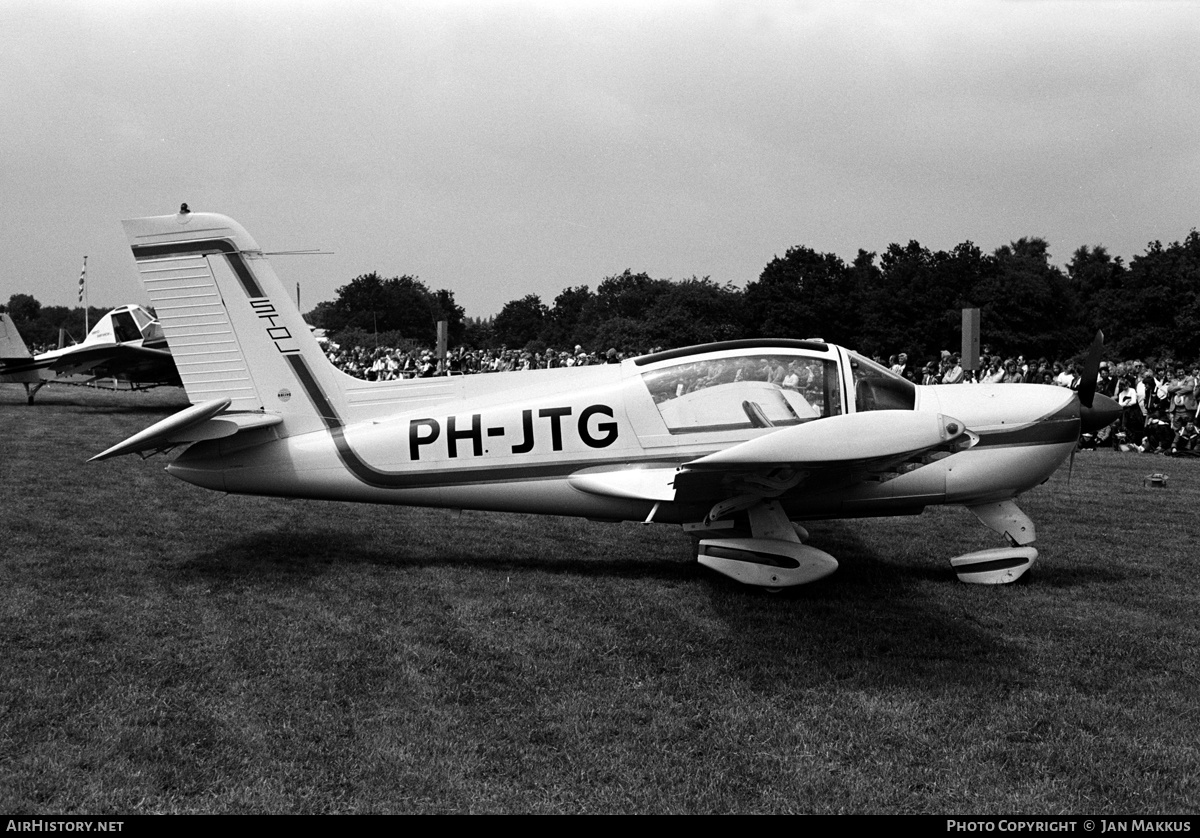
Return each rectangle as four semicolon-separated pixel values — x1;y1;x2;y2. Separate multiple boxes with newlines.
122;211;346;436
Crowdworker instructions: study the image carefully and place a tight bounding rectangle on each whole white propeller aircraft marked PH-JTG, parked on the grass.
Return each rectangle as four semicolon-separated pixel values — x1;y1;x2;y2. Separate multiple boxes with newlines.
92;213;1116;589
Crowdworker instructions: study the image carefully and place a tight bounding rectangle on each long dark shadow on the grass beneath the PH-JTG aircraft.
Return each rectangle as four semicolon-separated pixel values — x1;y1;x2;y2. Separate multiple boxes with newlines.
179;519;1027;694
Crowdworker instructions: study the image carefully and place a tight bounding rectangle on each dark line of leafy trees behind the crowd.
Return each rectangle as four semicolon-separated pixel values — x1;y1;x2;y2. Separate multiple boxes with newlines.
7;231;1200;360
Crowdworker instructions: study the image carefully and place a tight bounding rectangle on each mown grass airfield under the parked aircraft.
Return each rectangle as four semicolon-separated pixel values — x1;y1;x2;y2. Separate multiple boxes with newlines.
0;387;1200;815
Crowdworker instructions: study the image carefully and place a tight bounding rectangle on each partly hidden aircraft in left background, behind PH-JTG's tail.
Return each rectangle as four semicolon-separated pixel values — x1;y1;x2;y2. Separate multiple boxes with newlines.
0;305;180;405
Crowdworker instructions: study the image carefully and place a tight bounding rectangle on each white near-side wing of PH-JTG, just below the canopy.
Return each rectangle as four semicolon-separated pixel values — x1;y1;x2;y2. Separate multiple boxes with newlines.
684;411;968;471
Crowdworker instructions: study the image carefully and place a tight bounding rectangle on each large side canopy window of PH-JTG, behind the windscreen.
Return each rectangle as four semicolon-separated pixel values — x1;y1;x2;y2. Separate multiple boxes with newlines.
642;354;841;433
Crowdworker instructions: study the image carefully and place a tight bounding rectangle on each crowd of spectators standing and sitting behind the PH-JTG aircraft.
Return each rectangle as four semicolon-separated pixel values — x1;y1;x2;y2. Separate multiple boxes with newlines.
324;343;1200;456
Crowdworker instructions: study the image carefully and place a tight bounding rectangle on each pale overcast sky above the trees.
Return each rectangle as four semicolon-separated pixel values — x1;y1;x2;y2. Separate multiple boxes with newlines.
0;0;1200;317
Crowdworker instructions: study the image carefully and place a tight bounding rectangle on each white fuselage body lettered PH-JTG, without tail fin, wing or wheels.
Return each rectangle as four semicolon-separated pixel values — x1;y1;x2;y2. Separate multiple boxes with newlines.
168;347;1079;523
